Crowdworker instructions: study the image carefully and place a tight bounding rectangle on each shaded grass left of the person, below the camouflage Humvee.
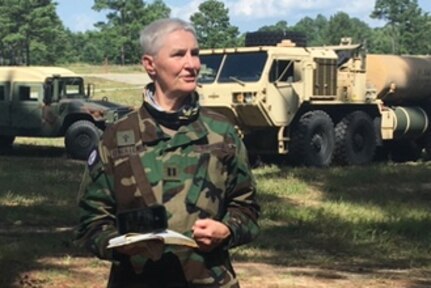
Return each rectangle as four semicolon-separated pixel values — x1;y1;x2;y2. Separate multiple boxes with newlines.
0;155;88;288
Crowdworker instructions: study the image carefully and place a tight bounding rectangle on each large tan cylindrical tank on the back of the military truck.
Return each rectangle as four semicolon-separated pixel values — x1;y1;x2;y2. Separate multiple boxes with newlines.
366;54;431;105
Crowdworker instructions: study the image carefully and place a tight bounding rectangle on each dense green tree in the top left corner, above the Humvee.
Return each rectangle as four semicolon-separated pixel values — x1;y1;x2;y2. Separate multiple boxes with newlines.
0;0;67;65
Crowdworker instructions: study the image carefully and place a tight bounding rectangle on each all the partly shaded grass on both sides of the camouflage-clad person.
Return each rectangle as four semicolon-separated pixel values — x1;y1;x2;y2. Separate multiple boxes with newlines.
0;144;431;287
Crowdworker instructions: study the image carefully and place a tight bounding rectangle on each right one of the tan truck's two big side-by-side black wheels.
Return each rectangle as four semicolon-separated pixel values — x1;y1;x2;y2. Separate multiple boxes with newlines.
334;111;376;165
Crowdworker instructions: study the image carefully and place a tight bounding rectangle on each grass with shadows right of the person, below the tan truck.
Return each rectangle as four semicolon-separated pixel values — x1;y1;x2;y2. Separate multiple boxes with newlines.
238;163;431;288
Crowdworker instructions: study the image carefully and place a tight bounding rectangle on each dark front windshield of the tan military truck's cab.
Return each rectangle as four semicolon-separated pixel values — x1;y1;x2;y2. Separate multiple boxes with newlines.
218;52;268;83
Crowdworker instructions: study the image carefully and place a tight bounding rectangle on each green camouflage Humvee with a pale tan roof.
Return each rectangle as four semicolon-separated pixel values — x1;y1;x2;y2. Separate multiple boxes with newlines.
0;67;131;159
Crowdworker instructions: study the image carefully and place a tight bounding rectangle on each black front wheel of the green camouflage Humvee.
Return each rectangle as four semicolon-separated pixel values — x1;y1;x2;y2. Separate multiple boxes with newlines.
65;120;102;160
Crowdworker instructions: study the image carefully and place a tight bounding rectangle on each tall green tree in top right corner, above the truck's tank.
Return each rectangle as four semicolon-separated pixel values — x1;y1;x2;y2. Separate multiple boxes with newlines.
370;0;431;54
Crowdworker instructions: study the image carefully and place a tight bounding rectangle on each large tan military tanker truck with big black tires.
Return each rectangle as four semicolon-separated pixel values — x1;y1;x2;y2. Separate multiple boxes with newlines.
198;34;431;166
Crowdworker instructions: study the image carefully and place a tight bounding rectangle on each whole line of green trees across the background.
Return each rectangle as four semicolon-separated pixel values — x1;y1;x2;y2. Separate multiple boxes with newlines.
0;0;431;65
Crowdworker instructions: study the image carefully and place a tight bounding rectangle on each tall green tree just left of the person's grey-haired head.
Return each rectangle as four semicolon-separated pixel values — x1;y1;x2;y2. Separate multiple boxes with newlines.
93;0;170;65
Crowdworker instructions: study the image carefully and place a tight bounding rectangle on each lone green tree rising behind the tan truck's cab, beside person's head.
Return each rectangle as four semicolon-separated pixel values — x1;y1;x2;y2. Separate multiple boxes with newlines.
190;0;239;48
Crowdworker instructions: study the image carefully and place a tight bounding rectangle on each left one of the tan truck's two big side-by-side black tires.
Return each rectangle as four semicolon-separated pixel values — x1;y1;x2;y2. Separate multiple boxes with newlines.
290;110;335;167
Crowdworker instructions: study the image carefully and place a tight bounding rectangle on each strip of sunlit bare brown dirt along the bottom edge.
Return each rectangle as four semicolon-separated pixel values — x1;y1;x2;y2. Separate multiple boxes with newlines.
16;257;431;288
